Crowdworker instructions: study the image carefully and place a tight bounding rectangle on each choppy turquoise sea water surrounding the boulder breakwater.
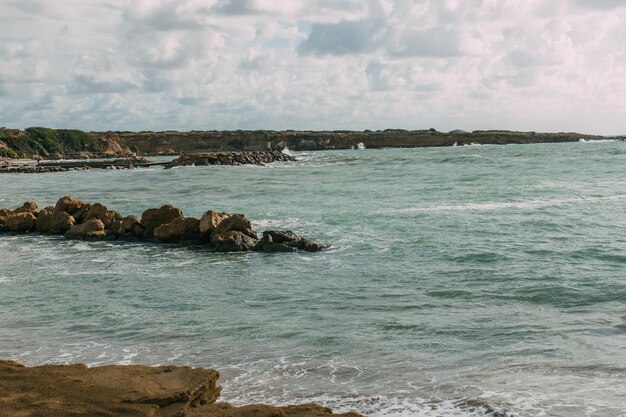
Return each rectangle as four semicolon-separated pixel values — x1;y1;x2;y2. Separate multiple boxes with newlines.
0;142;626;417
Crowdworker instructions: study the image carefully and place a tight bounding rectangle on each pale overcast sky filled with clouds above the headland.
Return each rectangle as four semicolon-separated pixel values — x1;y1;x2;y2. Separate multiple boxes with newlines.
0;0;626;134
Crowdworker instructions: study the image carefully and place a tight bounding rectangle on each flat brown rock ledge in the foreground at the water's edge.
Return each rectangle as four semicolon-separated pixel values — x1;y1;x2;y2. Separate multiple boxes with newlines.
0;361;363;417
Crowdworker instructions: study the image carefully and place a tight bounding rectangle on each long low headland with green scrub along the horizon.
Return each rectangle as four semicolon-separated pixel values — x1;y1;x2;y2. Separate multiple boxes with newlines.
0;127;624;159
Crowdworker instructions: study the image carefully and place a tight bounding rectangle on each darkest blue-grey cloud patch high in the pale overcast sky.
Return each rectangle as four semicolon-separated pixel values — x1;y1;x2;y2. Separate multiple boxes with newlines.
298;19;386;55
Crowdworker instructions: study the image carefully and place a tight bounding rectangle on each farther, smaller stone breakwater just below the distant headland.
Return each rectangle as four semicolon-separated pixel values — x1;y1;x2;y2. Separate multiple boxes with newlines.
165;151;295;168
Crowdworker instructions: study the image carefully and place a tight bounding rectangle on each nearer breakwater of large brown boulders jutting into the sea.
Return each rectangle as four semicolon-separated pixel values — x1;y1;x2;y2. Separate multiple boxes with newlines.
0;196;327;252
